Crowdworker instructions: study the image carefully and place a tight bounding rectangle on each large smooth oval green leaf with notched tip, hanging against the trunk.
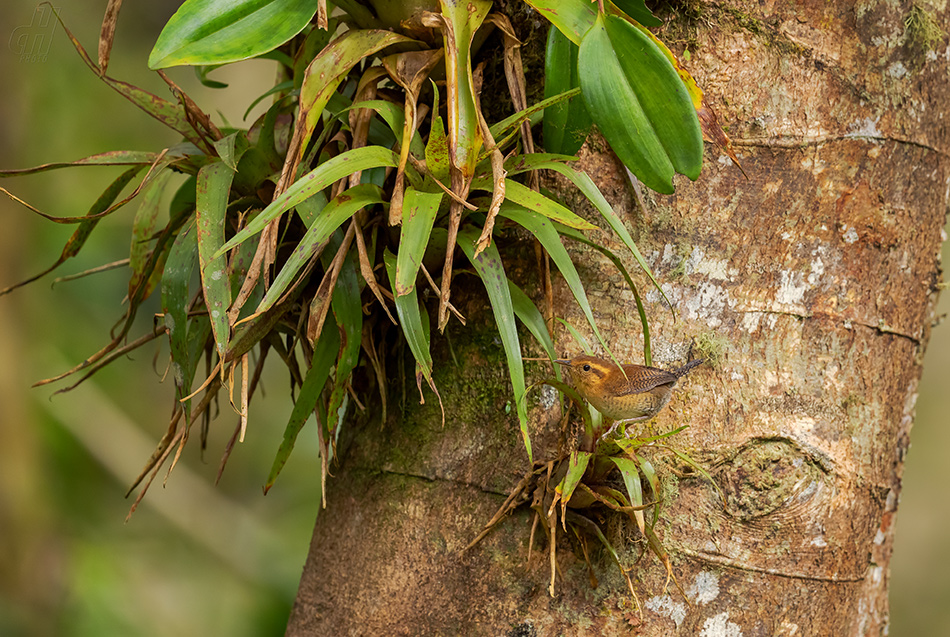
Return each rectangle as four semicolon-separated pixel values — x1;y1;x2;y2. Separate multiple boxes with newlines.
577;15;703;194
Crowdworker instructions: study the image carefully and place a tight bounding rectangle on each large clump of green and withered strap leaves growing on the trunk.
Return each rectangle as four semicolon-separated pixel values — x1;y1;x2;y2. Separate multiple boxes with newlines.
0;0;702;507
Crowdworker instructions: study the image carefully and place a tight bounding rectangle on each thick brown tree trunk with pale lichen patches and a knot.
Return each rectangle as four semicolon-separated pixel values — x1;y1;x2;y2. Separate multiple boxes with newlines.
288;0;950;636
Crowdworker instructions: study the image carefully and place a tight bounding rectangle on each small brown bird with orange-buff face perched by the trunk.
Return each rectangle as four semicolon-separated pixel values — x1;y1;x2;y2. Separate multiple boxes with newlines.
554;356;703;422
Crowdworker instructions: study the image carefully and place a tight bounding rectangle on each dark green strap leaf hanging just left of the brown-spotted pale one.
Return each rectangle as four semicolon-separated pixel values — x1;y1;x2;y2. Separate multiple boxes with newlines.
162;218;198;410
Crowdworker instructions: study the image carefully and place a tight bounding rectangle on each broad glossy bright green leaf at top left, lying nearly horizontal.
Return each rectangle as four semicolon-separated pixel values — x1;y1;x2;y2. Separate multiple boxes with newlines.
148;0;317;70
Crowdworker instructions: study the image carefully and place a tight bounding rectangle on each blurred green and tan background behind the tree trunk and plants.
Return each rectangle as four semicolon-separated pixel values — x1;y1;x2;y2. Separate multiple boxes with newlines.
0;0;950;636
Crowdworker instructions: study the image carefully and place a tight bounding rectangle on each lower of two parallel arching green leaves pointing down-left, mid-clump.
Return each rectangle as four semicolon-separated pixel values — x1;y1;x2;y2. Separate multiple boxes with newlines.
256;184;383;312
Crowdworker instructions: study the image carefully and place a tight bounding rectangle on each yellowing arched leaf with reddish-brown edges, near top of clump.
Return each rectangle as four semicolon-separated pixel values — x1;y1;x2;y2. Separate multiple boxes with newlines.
300;29;414;146
